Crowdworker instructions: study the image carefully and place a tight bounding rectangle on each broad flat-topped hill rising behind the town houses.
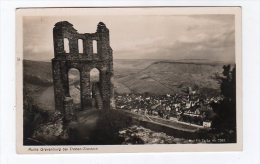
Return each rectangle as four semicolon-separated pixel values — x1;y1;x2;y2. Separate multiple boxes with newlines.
117;61;223;94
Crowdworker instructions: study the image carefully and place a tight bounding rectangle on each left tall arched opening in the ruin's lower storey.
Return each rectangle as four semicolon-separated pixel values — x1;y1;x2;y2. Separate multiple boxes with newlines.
68;68;81;108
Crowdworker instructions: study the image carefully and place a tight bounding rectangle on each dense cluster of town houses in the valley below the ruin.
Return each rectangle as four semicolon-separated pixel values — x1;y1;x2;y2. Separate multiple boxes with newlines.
115;92;222;128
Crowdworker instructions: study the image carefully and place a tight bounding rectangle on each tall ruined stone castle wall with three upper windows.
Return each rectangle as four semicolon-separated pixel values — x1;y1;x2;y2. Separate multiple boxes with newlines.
52;21;113;113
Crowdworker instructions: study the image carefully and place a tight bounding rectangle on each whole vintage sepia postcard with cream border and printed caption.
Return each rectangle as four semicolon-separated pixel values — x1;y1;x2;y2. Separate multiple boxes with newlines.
16;7;243;154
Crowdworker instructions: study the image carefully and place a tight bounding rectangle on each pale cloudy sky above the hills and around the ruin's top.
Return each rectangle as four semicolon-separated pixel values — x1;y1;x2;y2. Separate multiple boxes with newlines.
23;14;235;62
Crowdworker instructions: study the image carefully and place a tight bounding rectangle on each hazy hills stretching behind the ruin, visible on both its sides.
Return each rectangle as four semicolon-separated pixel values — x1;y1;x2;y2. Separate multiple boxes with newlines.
23;59;223;109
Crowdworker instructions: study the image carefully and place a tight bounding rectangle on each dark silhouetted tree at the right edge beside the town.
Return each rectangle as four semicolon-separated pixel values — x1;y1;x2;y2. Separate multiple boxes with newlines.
211;65;236;131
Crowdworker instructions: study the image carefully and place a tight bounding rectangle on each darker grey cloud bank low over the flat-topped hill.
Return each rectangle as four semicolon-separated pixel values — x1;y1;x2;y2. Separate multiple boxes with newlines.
118;21;235;62
